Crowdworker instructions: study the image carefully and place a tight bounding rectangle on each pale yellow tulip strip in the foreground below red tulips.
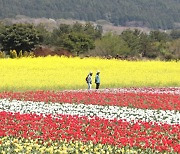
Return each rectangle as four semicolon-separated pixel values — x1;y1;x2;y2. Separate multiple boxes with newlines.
0;137;143;154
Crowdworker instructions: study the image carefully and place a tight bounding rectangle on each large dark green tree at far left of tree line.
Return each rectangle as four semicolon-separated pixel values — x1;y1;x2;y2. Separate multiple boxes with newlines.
0;24;41;54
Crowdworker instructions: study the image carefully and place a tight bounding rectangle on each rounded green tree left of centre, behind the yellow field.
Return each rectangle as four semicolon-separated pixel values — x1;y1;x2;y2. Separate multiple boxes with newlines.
51;22;99;55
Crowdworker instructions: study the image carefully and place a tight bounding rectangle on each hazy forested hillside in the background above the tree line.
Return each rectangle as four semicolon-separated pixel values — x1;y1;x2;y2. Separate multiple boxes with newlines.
0;0;180;29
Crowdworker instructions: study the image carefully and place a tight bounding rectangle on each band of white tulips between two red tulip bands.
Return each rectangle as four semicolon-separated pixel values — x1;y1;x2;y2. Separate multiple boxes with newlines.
0;99;180;124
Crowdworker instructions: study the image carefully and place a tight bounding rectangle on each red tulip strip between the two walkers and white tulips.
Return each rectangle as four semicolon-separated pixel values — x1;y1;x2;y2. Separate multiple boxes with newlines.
0;88;180;111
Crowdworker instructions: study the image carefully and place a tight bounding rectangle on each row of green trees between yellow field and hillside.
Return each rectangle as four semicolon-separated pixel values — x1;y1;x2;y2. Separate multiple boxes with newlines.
0;22;180;60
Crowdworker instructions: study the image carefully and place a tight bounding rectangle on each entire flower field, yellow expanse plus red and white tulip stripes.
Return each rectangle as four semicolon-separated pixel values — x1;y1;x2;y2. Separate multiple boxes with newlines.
0;57;180;154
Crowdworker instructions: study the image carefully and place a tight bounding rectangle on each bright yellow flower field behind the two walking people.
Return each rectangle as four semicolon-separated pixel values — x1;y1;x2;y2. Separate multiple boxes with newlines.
0;57;180;91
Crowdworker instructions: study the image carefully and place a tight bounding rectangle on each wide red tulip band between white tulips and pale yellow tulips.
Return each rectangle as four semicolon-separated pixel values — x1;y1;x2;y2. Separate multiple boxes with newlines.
0;112;180;152
